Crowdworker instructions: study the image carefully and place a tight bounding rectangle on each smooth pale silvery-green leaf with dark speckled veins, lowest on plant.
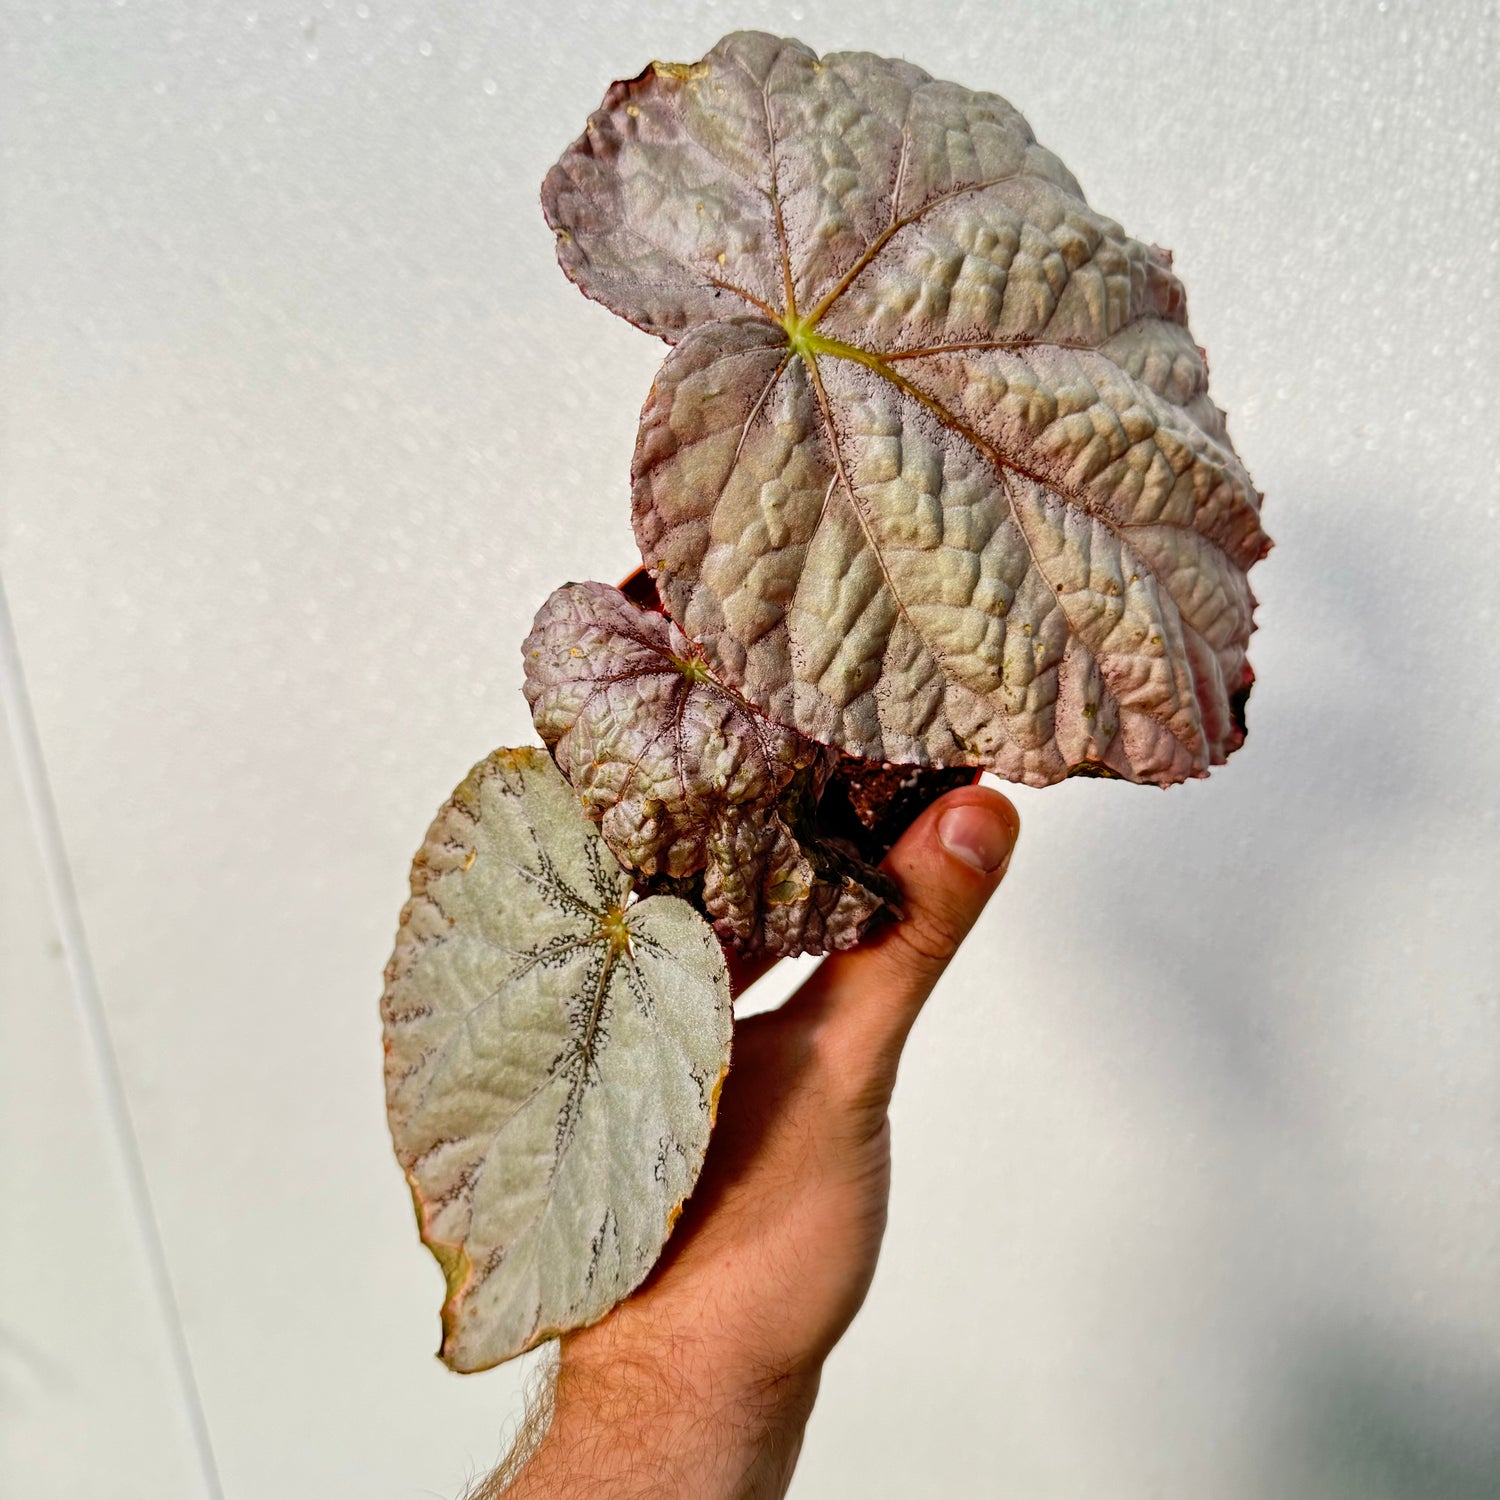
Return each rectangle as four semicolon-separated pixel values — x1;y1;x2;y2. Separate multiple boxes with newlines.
381;750;731;1371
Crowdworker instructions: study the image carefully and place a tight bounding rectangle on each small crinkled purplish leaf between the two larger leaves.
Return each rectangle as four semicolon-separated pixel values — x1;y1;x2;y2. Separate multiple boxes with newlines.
522;584;894;956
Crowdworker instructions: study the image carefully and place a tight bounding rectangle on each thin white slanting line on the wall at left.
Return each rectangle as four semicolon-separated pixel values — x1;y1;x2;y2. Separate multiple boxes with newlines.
0;578;224;1500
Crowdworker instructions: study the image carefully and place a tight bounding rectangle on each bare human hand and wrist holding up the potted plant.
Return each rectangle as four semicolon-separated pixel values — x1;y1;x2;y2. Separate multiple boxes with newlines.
498;786;1019;1500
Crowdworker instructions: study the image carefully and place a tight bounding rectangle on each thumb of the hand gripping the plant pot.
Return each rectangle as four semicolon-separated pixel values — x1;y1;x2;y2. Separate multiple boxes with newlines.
788;786;1020;1110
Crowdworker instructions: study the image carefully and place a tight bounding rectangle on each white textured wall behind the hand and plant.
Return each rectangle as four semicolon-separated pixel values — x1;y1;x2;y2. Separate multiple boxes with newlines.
0;0;1500;1500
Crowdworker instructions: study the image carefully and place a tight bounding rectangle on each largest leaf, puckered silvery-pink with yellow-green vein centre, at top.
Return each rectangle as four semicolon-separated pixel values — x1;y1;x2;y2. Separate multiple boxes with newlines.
543;33;1269;785
